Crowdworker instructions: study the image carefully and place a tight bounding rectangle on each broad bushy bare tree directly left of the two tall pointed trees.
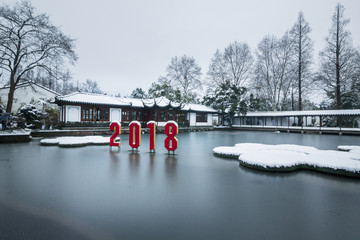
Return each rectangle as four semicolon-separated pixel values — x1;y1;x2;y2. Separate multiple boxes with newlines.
253;33;294;110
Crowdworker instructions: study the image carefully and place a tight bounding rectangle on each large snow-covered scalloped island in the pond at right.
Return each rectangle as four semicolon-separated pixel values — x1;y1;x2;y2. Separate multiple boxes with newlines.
213;143;360;177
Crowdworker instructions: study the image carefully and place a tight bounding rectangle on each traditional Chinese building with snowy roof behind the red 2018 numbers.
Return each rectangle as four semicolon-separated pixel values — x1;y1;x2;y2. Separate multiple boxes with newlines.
55;93;217;127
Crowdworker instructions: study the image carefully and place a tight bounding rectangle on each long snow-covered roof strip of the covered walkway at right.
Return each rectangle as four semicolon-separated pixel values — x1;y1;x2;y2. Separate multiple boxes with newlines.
240;109;360;117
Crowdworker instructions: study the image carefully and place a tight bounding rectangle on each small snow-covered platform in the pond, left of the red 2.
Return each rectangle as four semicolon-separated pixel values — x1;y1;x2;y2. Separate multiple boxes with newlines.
40;136;119;147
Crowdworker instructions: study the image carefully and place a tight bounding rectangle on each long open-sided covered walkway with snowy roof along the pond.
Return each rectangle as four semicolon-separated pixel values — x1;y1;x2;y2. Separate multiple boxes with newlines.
233;109;360;135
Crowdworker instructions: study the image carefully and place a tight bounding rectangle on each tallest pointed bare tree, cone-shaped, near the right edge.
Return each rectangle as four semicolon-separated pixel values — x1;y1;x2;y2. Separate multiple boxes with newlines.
317;4;356;109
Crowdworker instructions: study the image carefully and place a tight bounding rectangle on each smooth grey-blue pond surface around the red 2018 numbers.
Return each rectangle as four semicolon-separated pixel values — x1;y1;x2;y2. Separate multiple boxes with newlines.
0;131;360;240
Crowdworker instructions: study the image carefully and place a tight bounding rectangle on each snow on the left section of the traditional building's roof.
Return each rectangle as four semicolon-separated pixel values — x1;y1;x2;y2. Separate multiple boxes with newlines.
55;92;132;106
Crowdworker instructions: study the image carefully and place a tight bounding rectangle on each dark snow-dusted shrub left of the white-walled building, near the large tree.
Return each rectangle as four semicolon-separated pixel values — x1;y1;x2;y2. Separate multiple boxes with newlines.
18;104;49;129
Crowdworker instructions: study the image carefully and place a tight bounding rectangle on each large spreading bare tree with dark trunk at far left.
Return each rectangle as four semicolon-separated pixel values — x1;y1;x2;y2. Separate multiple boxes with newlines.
0;1;77;112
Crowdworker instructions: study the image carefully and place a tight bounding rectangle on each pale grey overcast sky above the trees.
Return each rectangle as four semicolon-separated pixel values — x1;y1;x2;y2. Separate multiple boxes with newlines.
1;0;360;96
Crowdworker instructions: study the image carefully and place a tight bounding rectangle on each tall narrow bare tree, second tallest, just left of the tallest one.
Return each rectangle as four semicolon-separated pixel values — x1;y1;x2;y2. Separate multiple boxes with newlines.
290;12;313;112
